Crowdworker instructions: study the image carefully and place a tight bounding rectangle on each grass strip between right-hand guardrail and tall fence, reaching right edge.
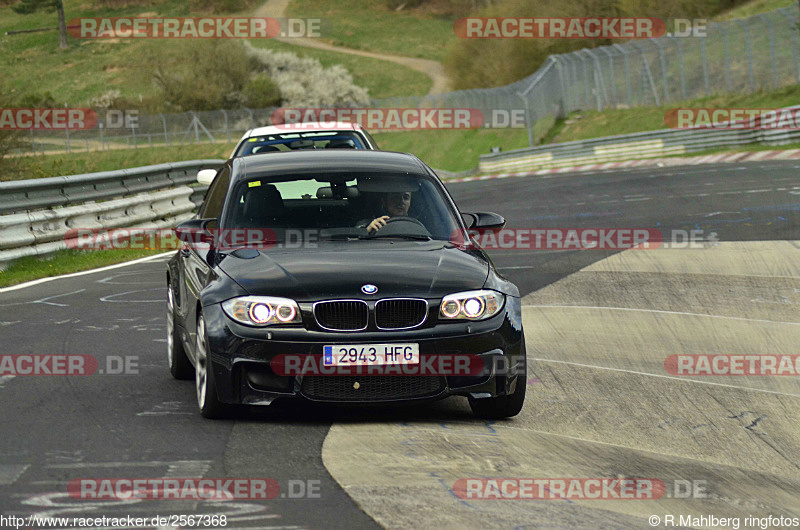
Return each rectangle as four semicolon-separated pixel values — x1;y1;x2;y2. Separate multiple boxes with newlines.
547;85;800;143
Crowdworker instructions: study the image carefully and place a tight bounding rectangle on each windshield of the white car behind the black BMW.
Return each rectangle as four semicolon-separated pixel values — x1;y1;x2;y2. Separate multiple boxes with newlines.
233;131;369;157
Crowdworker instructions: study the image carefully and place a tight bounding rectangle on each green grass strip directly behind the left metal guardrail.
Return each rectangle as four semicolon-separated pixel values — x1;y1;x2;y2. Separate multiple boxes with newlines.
0;143;235;181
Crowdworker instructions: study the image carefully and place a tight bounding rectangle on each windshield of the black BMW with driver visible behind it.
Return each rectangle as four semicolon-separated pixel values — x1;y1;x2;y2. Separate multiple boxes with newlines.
224;173;458;241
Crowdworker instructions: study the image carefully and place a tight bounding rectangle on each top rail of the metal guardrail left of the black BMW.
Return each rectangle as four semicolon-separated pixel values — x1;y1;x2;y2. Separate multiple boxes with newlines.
0;159;224;215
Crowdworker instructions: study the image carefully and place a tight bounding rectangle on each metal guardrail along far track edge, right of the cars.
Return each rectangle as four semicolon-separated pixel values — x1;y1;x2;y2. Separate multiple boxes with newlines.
478;106;800;173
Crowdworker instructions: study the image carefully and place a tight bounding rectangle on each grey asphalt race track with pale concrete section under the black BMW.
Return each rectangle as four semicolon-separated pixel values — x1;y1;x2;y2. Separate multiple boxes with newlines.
0;161;800;528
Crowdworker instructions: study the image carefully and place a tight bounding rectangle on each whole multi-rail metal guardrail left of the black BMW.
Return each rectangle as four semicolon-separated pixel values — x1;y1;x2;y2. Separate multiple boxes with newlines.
0;159;224;270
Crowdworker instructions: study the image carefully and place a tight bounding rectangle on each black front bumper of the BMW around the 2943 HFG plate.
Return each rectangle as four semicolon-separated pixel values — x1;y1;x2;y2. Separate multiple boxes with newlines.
195;297;525;405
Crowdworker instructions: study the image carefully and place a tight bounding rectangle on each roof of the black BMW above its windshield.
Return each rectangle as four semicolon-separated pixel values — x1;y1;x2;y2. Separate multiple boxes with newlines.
231;149;432;180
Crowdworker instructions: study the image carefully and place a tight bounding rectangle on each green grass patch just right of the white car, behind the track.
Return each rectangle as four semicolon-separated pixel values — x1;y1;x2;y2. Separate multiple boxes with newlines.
373;129;528;171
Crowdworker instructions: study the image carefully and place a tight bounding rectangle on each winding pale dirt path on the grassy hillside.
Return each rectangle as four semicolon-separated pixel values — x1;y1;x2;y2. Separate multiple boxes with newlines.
255;0;450;95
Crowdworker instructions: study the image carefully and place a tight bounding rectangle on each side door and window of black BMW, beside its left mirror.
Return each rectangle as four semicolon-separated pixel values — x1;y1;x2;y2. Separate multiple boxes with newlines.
180;165;231;358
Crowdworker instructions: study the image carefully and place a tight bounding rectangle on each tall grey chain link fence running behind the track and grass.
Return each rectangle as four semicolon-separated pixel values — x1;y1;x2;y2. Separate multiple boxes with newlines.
12;6;800;154
